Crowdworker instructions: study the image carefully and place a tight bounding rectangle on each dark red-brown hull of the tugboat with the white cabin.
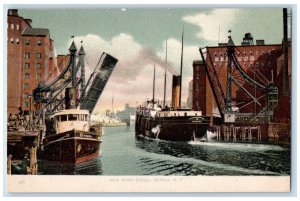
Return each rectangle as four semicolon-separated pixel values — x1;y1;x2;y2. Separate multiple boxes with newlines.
42;130;101;165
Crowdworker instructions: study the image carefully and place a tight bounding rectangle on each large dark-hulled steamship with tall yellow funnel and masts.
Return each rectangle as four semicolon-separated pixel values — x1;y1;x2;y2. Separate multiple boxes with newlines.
135;34;210;141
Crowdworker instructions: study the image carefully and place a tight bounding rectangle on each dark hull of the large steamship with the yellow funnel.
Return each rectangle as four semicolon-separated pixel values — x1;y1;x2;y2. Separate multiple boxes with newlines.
135;114;209;141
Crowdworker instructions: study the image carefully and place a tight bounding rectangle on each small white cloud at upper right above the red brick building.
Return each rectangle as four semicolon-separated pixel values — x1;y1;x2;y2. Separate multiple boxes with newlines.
183;8;241;44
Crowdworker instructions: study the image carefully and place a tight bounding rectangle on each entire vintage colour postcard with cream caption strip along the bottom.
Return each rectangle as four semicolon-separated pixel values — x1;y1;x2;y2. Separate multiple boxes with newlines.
5;6;294;193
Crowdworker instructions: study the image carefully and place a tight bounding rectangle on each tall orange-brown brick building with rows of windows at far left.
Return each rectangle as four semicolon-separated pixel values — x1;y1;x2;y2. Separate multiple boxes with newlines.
7;9;57;113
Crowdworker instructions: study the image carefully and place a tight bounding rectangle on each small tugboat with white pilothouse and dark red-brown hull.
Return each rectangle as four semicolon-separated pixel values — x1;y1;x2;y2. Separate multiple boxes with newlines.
42;109;102;164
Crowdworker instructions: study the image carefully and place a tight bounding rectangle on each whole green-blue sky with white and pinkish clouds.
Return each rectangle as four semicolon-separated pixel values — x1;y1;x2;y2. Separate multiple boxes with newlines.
19;7;283;111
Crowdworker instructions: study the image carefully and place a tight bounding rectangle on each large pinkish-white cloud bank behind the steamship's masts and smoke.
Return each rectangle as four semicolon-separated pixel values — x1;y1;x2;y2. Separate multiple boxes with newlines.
68;33;200;111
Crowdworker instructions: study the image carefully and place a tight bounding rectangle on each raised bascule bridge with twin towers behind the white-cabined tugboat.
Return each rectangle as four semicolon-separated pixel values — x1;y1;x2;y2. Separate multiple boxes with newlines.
33;42;118;116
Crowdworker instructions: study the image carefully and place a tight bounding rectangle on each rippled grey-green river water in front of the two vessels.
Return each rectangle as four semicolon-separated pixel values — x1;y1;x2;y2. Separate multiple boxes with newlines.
39;127;291;176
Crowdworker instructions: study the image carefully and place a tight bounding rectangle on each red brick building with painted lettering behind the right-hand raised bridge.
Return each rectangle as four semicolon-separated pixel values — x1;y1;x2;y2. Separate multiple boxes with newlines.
197;34;291;122
